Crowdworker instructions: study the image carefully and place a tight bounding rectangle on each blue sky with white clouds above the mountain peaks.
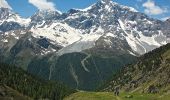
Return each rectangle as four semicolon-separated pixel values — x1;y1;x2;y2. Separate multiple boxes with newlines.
3;0;170;19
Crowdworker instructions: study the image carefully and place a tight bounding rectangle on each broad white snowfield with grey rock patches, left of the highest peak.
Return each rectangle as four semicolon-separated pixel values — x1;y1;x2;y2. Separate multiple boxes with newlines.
31;22;81;47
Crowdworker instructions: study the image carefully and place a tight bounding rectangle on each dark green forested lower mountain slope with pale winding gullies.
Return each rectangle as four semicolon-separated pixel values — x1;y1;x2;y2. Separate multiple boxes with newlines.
27;53;135;90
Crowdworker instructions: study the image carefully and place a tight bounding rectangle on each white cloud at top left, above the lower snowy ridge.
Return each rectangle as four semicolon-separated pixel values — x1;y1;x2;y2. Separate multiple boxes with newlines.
28;0;56;10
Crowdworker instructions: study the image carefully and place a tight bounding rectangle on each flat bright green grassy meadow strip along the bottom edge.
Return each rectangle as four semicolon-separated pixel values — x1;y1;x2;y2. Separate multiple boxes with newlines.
64;92;170;100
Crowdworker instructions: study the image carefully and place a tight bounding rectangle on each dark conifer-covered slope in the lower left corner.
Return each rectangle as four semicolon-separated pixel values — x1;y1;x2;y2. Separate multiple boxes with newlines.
0;63;75;100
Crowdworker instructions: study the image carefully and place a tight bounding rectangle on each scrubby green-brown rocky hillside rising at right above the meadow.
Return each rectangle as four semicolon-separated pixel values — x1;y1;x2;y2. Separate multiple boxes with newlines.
102;44;170;93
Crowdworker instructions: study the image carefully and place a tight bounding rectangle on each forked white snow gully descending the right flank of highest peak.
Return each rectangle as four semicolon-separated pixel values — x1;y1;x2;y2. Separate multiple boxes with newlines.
118;19;157;54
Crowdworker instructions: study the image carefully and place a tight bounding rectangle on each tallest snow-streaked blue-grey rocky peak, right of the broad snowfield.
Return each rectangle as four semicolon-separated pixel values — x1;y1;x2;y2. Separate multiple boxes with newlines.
60;0;170;55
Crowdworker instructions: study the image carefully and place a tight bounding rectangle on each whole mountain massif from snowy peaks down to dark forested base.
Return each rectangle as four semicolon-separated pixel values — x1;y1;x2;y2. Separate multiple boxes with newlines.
0;0;170;89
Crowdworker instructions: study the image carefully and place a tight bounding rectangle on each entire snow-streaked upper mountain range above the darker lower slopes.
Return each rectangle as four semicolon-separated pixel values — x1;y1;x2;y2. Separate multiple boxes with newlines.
0;0;170;55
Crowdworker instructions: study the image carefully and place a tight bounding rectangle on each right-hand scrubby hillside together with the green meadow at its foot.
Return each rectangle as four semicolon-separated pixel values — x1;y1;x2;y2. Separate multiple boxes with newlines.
64;44;170;100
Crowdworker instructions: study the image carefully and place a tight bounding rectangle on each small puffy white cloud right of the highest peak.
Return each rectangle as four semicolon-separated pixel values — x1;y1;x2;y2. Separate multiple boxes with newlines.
143;0;167;15
